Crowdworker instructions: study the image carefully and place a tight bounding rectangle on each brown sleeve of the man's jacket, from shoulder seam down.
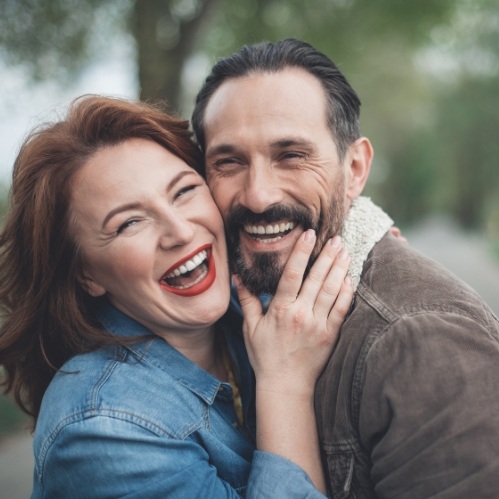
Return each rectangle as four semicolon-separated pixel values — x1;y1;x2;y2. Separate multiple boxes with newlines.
359;311;499;499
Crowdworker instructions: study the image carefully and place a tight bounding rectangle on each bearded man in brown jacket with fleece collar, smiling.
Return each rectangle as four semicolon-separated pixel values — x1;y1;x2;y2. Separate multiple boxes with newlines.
193;40;499;499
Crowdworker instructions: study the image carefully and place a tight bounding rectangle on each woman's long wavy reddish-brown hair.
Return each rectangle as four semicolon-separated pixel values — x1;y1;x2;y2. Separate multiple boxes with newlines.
0;96;201;420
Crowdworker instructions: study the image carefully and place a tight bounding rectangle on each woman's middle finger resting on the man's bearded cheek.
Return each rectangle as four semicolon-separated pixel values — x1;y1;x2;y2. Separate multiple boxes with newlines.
299;236;345;302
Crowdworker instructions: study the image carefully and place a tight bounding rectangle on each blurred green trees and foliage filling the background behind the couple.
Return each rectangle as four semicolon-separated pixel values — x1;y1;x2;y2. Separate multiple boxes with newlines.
0;0;499;438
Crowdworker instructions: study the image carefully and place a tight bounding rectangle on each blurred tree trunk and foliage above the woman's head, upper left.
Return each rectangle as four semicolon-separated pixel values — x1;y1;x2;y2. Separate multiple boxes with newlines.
0;0;216;109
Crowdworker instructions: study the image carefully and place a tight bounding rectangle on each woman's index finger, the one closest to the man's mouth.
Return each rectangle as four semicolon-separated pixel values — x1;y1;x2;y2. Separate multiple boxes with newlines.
271;229;316;307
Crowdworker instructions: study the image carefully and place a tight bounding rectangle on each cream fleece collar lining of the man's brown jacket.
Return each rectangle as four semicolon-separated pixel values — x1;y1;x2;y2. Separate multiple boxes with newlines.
341;196;393;290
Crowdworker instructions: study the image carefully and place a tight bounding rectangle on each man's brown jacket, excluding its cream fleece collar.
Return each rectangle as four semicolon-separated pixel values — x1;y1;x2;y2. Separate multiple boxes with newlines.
316;235;499;499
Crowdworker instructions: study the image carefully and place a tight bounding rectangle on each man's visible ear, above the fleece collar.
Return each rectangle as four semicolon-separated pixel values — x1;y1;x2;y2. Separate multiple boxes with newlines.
345;137;374;201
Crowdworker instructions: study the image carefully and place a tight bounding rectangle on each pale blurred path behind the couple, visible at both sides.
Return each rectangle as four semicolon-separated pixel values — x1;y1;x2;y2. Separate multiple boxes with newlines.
0;218;499;499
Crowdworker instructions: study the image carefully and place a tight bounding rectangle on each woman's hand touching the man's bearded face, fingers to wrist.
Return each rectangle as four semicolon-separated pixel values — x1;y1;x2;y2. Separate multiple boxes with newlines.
235;230;353;395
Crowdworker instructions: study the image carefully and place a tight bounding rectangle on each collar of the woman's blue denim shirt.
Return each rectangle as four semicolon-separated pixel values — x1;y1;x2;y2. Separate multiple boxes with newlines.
96;300;222;405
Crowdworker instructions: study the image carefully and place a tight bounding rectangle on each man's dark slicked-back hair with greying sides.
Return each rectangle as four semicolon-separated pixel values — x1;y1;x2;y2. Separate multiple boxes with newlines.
192;39;360;159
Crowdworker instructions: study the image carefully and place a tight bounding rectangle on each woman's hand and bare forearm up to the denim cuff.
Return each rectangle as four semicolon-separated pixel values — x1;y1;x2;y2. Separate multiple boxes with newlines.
236;230;353;493
